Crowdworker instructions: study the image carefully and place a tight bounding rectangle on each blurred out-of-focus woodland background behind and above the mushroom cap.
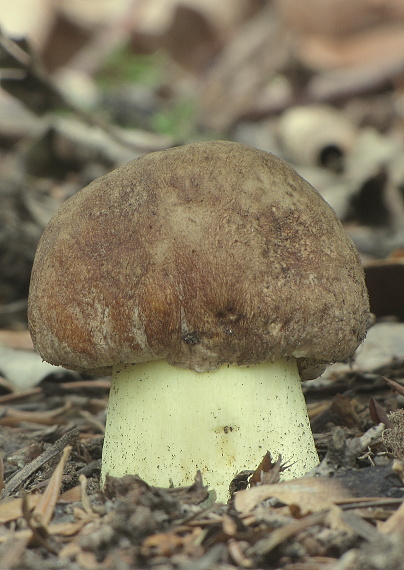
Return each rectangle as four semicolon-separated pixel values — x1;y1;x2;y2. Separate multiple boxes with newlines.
0;0;404;329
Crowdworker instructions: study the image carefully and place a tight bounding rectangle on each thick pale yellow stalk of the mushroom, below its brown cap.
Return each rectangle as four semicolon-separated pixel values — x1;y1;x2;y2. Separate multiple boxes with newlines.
102;359;318;501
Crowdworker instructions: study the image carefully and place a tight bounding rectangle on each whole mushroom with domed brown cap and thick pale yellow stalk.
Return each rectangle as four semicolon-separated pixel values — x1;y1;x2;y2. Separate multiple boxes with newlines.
29;141;369;501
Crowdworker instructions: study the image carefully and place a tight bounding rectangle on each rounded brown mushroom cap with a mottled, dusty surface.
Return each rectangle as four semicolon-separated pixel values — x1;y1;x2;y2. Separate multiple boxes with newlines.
29;141;369;371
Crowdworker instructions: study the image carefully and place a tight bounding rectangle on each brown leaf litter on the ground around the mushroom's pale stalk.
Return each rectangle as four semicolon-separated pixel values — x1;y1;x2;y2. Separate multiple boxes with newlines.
0;362;404;570
